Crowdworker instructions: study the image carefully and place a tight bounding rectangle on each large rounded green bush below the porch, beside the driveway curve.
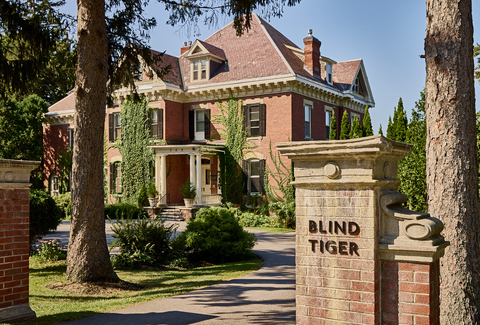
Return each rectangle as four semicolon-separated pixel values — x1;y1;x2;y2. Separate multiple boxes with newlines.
172;207;256;263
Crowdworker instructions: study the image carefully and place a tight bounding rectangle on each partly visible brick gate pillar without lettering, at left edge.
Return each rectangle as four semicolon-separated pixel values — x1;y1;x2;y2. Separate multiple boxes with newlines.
0;159;40;323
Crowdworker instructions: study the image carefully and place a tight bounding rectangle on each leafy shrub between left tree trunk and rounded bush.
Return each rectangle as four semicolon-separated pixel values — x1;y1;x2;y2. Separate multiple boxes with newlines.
111;217;178;268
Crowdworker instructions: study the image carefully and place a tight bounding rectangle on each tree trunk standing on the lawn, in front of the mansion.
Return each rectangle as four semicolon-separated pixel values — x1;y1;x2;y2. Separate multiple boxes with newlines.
66;0;118;282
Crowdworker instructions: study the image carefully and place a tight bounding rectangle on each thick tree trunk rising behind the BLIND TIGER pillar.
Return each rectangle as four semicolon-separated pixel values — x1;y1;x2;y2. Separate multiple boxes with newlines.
425;0;480;325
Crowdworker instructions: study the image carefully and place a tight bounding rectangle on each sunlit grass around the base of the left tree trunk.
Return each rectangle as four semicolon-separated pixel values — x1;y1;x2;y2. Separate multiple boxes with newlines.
14;257;262;325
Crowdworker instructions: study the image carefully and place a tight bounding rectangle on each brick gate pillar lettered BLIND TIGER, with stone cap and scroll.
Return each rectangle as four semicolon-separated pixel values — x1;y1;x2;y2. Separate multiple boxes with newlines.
277;135;449;325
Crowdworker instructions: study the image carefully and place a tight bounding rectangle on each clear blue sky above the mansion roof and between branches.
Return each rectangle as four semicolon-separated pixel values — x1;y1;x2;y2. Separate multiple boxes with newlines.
65;0;480;133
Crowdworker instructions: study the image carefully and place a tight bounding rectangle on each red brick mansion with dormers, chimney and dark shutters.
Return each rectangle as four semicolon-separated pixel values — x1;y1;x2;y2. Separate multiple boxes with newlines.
44;15;375;204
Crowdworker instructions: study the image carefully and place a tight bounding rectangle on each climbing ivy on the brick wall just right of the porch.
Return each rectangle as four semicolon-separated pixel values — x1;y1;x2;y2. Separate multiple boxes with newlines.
212;97;248;204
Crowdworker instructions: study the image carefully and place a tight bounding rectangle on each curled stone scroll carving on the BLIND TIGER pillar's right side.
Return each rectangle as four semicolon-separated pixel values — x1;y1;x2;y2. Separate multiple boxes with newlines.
379;191;449;262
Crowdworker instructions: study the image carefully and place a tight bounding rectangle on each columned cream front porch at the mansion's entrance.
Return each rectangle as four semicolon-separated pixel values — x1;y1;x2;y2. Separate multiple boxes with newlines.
151;144;223;207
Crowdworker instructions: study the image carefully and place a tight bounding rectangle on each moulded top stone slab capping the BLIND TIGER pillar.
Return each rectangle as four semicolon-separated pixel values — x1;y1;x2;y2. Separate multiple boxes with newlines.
276;134;412;159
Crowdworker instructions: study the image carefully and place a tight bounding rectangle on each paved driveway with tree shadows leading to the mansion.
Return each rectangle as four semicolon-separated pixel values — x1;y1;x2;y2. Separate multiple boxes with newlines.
45;220;295;325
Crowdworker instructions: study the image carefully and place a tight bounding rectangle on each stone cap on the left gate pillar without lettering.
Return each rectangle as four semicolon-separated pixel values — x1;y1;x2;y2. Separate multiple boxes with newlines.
0;159;40;188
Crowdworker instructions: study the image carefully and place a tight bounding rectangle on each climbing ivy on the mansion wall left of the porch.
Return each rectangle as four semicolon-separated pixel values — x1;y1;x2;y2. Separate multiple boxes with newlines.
114;98;153;202
